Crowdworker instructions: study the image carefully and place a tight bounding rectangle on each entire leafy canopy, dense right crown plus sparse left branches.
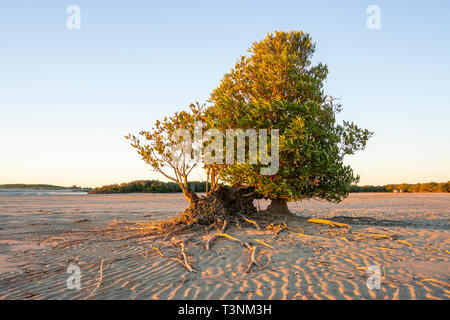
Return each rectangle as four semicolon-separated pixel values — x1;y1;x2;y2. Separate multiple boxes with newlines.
127;31;372;208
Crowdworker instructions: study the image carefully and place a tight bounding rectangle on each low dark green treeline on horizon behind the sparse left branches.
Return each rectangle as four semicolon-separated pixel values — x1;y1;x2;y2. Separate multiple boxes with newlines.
90;180;213;194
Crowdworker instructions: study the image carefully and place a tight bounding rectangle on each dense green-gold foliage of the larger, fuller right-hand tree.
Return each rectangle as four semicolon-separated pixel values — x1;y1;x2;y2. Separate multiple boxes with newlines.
206;31;372;201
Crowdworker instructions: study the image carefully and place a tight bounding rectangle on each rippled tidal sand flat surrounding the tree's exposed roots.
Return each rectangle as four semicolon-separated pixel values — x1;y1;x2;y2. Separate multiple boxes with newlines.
0;193;450;299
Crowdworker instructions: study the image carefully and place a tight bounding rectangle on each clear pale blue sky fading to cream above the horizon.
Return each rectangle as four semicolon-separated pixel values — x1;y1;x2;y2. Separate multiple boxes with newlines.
0;0;450;186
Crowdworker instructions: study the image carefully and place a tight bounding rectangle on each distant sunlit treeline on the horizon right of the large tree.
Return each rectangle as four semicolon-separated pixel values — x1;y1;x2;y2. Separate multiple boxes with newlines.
350;181;450;192
